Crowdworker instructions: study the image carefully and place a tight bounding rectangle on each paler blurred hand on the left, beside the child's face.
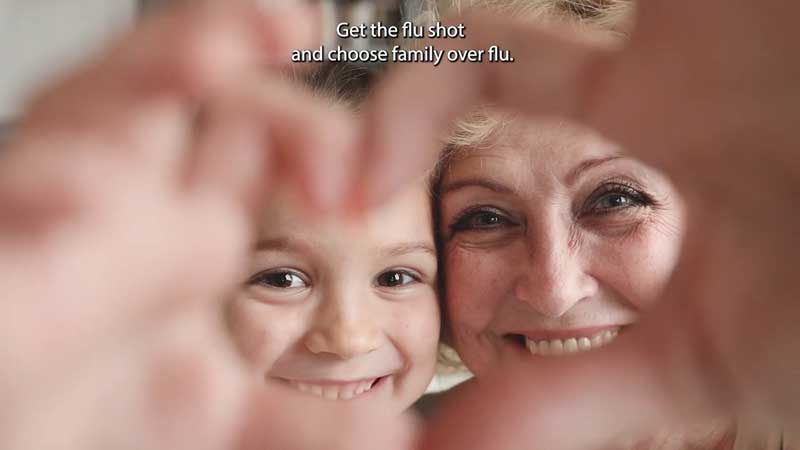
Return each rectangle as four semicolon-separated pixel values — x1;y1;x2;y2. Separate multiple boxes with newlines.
0;1;384;449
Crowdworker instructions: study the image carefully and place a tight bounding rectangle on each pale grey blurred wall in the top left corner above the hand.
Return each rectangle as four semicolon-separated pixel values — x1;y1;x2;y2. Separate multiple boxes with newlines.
0;0;137;123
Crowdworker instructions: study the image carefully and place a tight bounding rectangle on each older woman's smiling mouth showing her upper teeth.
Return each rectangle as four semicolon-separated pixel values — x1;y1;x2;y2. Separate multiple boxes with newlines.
509;325;622;356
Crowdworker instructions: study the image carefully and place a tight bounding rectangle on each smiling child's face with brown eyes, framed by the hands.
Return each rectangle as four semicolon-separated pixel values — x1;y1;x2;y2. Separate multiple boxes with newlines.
229;183;439;411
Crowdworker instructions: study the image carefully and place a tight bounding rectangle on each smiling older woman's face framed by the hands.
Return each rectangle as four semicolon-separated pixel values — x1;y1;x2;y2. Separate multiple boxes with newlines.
440;120;683;376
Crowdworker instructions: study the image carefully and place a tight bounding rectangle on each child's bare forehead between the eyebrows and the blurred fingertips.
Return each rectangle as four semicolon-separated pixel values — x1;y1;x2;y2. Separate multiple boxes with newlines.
259;182;433;245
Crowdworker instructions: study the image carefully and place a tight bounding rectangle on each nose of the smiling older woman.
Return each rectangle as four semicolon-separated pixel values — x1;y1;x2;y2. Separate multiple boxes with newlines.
514;227;598;318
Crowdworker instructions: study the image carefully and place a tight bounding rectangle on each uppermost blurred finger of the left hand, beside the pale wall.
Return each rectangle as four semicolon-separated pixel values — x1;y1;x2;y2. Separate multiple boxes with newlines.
29;0;318;109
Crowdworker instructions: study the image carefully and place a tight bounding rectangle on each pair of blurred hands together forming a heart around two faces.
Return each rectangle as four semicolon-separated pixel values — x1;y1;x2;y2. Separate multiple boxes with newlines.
0;0;800;450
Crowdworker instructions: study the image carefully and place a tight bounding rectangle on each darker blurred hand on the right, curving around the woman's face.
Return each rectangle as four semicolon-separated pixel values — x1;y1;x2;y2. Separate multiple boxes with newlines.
364;0;800;450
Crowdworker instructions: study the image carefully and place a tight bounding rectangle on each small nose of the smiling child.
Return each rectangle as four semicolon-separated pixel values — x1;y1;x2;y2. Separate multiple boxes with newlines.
305;292;381;359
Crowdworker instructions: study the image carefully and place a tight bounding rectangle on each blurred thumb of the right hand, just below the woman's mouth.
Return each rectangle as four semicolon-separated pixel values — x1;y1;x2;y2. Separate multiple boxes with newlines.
422;330;718;450
